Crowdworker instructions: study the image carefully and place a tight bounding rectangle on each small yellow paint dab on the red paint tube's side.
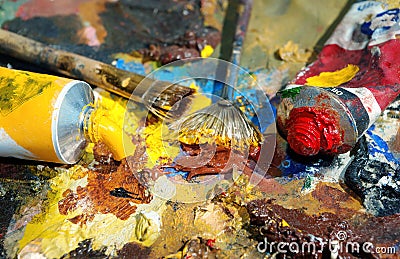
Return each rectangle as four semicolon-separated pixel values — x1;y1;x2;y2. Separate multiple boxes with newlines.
306;64;359;87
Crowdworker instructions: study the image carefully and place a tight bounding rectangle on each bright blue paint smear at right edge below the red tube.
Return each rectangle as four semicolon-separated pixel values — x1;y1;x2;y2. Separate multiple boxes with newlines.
366;125;400;165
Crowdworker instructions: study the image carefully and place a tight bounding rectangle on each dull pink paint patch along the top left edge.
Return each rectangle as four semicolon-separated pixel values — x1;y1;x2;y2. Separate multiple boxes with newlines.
15;0;92;20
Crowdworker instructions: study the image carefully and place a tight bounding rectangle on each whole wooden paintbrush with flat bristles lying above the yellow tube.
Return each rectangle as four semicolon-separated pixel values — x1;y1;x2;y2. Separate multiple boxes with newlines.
0;29;195;119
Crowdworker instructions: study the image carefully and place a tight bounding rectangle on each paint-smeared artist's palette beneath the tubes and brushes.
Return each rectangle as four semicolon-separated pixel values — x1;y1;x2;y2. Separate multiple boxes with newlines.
0;0;400;258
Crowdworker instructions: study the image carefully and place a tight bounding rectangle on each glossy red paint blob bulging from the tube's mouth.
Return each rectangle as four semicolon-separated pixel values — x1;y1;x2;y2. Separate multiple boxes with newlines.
287;107;342;156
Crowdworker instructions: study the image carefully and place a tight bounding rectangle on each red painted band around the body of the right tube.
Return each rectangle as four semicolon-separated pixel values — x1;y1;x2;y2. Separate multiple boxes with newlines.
294;39;400;110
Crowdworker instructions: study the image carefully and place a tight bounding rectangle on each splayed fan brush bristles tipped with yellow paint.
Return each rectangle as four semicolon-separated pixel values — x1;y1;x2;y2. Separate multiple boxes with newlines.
171;100;263;149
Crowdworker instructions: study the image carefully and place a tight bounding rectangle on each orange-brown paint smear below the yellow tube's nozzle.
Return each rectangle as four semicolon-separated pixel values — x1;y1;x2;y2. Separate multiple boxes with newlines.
58;149;152;224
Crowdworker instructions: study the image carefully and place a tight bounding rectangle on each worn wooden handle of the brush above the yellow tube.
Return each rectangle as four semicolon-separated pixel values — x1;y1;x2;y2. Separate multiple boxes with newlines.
0;29;161;99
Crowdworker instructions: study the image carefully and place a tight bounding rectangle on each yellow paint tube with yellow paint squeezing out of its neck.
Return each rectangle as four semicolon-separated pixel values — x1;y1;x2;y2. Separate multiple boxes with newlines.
0;67;133;164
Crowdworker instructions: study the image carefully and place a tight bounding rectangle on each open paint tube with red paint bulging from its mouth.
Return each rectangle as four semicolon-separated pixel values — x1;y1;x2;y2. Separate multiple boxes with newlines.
277;1;400;156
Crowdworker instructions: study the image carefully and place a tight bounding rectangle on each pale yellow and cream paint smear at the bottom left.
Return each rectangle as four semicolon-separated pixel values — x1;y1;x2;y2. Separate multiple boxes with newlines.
19;165;165;258
